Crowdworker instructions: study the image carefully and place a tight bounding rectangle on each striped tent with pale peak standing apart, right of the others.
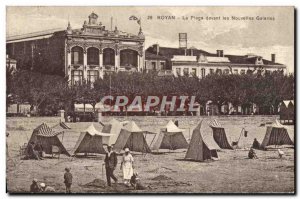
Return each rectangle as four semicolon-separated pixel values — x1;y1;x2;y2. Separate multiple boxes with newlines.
261;120;294;149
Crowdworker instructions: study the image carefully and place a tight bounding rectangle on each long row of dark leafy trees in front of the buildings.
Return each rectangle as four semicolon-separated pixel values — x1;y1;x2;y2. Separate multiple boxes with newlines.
7;70;294;115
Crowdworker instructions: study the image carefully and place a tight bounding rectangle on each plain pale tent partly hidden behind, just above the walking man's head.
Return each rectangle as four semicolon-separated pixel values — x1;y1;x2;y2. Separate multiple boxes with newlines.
102;118;123;145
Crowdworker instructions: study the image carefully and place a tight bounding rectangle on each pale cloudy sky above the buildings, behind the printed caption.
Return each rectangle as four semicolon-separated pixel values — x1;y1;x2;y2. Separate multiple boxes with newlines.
6;6;294;73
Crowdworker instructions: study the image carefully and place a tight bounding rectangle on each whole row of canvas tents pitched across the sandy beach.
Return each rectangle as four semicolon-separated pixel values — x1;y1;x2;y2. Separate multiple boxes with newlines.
29;119;294;161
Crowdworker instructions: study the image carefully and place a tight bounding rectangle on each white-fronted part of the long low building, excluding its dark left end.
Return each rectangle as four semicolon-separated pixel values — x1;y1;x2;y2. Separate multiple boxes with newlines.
171;50;287;78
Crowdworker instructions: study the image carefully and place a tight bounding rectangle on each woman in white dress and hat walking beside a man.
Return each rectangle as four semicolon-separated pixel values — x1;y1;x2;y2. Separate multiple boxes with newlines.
120;148;133;185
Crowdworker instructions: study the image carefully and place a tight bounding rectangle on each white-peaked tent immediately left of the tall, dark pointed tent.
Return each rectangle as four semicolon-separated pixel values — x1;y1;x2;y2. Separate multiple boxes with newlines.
152;120;188;150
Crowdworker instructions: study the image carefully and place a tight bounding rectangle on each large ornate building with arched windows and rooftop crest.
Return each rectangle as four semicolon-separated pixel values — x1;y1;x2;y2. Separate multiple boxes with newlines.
6;13;145;84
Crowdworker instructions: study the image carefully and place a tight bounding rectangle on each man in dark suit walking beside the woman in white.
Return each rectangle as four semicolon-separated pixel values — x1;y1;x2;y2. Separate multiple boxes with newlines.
104;146;118;186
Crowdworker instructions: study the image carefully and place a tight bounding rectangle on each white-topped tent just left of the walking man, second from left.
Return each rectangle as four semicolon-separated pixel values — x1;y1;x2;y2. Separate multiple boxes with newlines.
72;124;111;154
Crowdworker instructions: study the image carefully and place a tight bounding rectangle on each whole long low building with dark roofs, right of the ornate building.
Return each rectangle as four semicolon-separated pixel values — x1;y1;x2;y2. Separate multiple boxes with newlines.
145;44;287;78
